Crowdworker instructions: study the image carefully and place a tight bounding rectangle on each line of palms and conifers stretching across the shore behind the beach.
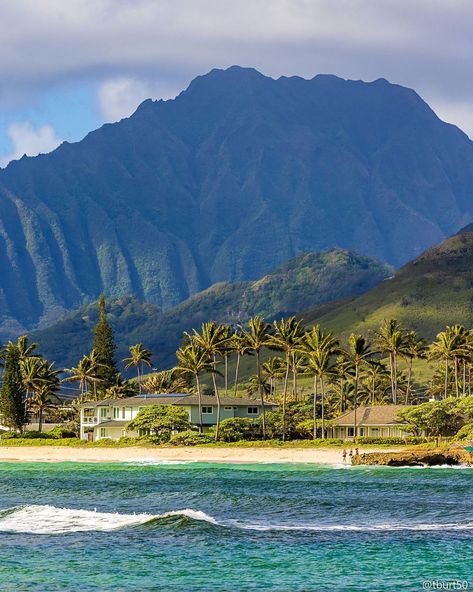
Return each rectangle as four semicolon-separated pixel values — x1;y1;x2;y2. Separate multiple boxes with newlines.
0;296;473;440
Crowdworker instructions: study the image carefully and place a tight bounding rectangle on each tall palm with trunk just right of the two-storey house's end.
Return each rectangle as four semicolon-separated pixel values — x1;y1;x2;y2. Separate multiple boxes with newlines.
269;316;304;440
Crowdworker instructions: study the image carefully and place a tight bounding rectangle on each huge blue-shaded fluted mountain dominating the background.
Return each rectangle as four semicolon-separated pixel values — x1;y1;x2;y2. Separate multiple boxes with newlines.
0;67;473;338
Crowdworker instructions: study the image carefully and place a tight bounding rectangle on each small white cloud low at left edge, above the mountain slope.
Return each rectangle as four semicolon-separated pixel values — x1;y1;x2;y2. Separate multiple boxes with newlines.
0;121;62;166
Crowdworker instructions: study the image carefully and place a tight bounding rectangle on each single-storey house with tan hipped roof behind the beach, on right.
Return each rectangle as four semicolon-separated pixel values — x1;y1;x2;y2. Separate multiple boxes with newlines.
331;405;412;440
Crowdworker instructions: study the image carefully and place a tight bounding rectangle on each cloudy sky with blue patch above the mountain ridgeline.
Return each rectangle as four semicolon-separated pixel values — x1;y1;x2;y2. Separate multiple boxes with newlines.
0;0;473;166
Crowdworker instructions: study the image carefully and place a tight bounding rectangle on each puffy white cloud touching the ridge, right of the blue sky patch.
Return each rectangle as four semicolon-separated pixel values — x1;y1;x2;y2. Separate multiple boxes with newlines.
98;77;178;121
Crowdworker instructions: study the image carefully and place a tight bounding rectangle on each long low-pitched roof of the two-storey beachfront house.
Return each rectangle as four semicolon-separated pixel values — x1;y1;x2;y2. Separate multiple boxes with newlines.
81;395;277;407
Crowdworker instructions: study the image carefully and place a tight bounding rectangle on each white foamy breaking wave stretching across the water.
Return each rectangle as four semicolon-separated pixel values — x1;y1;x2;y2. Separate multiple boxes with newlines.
0;505;473;534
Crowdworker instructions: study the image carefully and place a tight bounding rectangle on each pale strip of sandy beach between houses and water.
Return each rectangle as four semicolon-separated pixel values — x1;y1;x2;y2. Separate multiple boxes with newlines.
0;446;399;464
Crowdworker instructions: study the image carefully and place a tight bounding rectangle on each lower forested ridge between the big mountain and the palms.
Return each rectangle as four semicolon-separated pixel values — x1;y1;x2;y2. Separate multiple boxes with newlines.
30;249;393;368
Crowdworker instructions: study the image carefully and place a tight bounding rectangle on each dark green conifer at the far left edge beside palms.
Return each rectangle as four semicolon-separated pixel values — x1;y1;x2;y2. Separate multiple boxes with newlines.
0;341;27;431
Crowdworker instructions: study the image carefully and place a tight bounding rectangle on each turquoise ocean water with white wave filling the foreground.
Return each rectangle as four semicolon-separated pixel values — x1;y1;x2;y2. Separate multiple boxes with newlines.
0;462;473;592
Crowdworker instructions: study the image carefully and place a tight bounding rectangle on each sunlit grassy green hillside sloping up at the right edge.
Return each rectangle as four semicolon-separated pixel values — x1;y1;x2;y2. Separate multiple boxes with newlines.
303;225;473;340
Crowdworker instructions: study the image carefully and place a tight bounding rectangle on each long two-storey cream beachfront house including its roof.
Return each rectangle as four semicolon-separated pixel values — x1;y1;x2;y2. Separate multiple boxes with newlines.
80;394;277;440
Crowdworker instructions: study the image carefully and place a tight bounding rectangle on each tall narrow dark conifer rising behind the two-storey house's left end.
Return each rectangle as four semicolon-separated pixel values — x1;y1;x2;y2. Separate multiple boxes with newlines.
93;294;120;390
